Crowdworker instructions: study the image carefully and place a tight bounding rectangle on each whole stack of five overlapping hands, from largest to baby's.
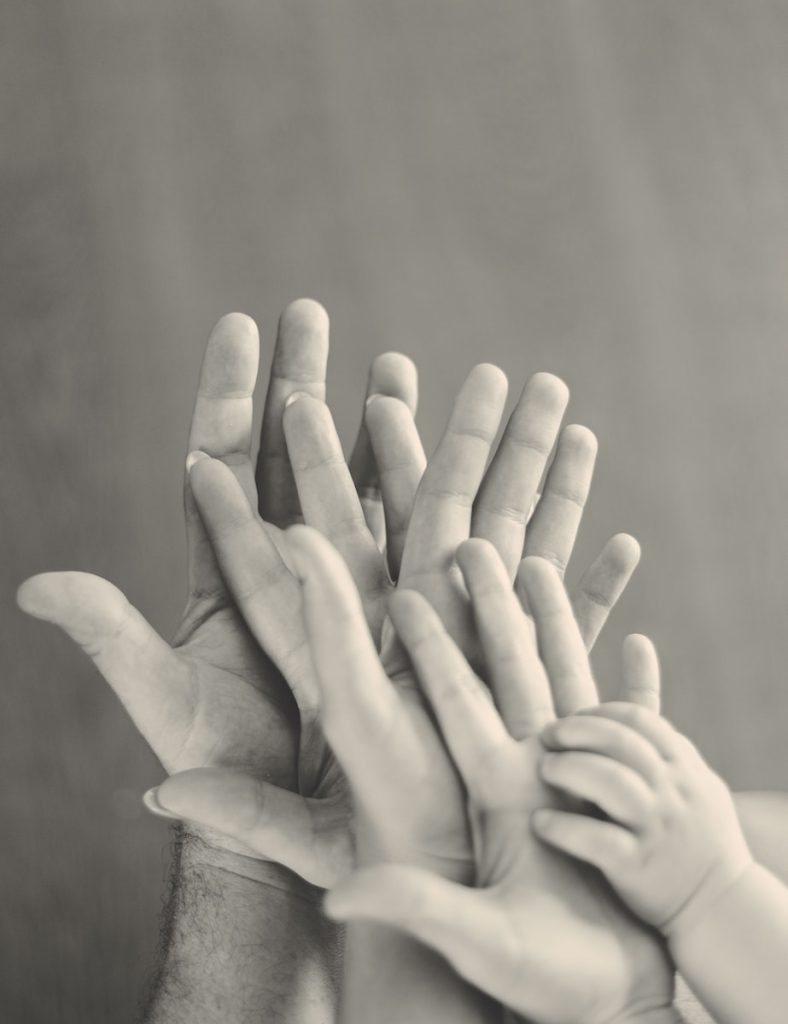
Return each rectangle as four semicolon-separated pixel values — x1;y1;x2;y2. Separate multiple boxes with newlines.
19;300;782;1024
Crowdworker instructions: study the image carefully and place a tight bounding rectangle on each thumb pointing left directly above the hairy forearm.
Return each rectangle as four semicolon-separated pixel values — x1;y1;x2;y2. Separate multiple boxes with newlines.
153;768;352;889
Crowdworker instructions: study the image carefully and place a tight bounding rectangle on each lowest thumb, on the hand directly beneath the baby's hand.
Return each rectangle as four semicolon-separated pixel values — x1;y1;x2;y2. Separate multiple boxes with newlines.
324;864;505;978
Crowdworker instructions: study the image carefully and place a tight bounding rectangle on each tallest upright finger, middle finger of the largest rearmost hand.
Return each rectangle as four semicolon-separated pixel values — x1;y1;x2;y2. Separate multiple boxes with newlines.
256;299;329;527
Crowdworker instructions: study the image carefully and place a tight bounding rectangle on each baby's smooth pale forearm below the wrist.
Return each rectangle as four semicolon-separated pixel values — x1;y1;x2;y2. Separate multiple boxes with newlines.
669;864;788;1024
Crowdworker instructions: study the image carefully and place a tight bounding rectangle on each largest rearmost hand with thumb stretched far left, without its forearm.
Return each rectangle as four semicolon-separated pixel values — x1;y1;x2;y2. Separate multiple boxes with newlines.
18;300;415;883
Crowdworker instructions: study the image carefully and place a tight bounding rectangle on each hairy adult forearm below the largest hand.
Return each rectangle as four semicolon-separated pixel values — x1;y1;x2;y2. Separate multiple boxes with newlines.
144;837;341;1024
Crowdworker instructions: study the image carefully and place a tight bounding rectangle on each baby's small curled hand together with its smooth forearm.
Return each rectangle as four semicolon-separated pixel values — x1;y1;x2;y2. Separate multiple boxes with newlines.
534;703;788;1024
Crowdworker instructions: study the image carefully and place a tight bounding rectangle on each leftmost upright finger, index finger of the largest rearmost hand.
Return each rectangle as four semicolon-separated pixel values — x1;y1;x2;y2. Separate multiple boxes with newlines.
184;313;260;599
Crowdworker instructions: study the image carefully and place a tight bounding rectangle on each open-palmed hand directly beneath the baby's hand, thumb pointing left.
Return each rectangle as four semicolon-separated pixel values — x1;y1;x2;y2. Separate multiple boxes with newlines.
323;538;672;1024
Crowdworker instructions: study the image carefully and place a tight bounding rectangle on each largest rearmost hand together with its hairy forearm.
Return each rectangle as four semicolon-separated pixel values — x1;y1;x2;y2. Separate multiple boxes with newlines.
18;300;415;1024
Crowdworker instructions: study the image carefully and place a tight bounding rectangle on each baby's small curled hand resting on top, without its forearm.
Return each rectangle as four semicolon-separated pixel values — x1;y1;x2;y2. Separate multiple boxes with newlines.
532;702;752;936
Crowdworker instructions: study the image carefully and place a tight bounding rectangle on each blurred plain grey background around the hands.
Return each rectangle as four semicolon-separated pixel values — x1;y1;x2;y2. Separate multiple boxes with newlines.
0;0;788;1024
